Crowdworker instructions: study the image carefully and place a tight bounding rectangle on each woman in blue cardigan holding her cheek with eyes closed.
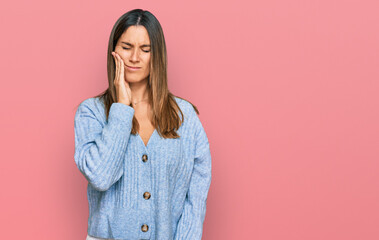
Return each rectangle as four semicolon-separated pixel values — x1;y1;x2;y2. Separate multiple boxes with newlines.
74;9;211;240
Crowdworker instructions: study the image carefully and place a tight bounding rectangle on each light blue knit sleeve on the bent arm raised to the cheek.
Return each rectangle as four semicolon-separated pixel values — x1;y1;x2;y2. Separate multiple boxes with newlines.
74;101;134;191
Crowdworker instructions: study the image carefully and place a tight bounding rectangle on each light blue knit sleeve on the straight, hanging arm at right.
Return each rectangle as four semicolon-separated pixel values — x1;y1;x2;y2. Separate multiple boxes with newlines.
174;107;211;240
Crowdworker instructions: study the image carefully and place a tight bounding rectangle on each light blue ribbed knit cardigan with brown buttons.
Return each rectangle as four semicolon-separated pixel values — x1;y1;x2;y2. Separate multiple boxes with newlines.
74;97;211;240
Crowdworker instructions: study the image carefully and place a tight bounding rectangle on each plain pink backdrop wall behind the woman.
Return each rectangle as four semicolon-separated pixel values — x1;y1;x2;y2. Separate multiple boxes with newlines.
0;0;379;240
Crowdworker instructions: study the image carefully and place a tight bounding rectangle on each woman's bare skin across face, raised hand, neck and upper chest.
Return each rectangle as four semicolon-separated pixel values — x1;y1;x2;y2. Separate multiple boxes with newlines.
112;26;155;145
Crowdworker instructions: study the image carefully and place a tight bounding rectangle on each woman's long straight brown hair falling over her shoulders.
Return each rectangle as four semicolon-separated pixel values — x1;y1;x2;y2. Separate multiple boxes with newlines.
95;9;199;138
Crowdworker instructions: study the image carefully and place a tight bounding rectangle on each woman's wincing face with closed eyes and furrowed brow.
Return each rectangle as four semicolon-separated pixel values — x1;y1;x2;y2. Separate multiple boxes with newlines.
115;26;150;82
